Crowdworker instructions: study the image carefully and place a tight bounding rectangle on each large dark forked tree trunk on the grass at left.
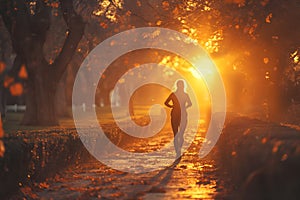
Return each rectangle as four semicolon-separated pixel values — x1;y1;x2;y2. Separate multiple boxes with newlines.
0;0;85;125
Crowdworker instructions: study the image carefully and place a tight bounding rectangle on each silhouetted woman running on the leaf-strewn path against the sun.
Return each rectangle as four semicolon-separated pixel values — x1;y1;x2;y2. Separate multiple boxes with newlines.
165;80;192;156
